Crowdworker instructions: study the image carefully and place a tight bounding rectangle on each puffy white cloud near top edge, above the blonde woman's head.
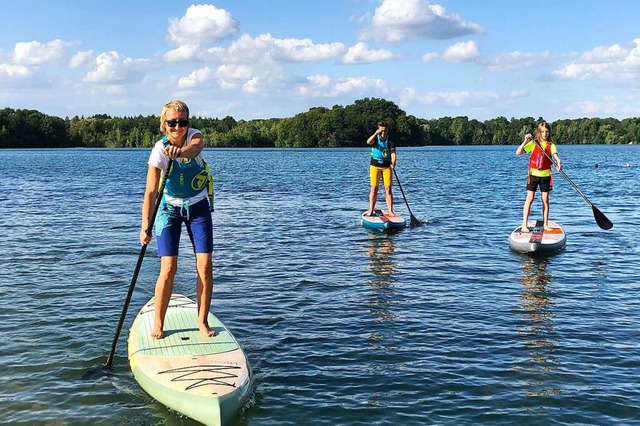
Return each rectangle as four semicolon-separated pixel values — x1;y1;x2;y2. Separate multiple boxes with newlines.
167;4;240;46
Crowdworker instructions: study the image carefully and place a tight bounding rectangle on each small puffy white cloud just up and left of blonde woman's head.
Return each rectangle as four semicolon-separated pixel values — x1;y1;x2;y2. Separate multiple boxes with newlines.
82;50;150;84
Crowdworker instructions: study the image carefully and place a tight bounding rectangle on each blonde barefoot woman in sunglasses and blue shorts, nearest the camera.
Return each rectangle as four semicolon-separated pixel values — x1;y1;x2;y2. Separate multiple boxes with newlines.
140;100;215;339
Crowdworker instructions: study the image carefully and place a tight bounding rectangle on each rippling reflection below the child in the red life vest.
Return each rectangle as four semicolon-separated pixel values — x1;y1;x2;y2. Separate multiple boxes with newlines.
518;256;560;397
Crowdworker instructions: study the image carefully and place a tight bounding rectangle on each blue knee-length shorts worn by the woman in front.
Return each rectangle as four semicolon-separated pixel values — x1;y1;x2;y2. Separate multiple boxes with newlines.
155;198;213;257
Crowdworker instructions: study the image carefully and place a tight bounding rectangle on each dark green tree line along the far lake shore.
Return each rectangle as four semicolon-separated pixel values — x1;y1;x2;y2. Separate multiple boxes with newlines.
0;98;640;148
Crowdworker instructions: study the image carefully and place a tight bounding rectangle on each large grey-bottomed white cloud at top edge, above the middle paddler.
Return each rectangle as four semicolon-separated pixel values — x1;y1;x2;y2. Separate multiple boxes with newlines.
360;0;484;42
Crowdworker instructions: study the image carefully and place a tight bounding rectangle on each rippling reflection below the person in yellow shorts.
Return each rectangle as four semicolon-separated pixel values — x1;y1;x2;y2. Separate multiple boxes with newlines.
367;232;396;321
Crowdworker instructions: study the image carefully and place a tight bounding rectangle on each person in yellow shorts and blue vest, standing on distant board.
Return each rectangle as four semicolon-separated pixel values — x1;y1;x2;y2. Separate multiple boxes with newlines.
365;121;396;216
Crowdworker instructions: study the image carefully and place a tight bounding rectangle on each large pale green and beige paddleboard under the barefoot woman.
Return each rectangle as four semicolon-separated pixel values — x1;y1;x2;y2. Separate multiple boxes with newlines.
129;294;253;425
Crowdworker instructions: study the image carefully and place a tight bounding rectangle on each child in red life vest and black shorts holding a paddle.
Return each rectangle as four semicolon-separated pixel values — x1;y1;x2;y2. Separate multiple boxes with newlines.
516;121;562;232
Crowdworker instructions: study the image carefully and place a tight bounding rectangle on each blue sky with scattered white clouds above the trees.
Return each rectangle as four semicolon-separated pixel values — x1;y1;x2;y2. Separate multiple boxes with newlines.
0;0;640;121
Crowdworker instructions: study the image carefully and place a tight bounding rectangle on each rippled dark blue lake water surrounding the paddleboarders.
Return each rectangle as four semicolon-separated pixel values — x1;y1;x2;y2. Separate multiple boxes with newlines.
0;145;640;425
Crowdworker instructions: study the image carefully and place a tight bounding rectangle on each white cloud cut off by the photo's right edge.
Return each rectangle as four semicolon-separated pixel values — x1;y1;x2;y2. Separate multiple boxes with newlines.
552;38;640;81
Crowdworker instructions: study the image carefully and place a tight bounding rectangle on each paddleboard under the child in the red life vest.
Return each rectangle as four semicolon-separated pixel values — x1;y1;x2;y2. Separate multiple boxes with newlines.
509;220;567;253
